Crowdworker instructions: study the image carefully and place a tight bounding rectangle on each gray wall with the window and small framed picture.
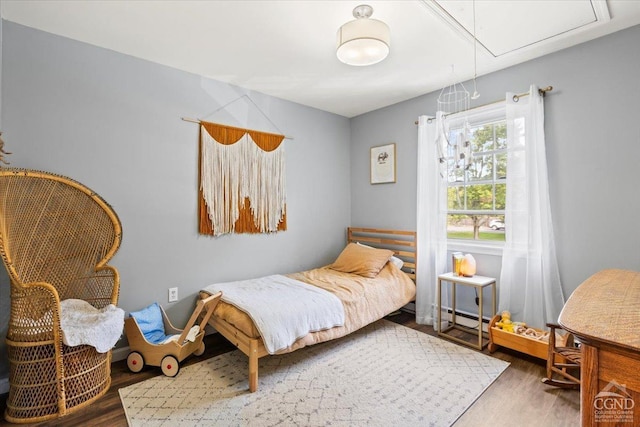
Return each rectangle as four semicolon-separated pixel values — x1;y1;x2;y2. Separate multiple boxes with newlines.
351;22;640;309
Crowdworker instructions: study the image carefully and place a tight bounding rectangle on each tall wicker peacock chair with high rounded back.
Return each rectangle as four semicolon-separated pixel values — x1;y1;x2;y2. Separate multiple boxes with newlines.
0;169;122;423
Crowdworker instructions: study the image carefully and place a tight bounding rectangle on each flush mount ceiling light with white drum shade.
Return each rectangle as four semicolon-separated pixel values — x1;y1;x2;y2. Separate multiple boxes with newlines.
336;4;391;66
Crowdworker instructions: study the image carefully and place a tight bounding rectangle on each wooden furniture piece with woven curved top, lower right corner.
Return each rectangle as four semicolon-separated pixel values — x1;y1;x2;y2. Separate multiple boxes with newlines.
559;270;640;427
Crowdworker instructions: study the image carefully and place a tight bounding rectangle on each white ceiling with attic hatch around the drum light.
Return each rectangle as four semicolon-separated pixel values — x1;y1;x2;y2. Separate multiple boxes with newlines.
0;0;640;117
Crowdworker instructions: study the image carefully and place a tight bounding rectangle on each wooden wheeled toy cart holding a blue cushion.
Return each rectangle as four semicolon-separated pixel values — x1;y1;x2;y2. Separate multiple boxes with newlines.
124;292;222;377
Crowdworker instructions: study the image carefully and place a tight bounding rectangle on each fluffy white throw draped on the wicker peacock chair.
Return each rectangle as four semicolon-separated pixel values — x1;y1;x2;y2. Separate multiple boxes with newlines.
60;299;124;353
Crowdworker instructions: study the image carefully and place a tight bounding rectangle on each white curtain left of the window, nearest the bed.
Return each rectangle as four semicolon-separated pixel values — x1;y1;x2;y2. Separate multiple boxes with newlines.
416;112;447;325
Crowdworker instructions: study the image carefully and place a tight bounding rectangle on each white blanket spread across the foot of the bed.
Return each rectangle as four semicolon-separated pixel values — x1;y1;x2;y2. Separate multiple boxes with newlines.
203;275;345;354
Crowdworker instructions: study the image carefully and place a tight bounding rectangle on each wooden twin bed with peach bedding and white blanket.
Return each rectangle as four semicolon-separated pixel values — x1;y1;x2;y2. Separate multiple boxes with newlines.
201;228;416;392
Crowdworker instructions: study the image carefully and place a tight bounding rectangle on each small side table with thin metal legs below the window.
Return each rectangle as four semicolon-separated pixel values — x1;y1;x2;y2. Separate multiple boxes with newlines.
434;273;496;350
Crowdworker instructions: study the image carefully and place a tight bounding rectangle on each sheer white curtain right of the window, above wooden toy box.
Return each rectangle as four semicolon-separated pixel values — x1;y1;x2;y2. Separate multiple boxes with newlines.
499;85;564;328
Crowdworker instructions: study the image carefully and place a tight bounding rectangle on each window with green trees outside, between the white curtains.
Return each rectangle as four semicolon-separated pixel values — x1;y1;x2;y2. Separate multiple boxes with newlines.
445;104;507;242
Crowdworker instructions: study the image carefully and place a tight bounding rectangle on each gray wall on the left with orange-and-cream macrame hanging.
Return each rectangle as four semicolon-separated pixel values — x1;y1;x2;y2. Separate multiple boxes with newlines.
0;21;351;379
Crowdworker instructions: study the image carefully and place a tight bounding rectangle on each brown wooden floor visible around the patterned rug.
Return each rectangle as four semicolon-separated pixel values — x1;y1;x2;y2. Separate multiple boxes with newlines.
0;313;580;427
